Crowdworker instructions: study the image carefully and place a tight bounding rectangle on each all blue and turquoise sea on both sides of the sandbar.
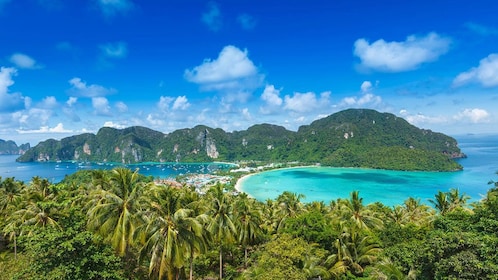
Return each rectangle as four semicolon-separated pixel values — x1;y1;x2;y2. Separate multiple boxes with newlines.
0;135;498;205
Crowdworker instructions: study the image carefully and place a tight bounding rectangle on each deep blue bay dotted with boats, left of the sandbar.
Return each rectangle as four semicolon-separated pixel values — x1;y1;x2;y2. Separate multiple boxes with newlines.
0;159;233;183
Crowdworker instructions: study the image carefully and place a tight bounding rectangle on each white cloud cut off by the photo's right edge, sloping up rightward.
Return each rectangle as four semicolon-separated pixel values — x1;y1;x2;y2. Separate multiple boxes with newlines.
453;53;498;87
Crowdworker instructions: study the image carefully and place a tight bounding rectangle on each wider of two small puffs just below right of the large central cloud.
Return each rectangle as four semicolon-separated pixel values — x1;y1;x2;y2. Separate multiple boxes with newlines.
284;91;330;113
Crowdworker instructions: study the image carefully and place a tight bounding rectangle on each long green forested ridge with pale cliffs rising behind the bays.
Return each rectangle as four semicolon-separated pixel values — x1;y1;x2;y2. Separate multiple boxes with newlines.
18;109;463;171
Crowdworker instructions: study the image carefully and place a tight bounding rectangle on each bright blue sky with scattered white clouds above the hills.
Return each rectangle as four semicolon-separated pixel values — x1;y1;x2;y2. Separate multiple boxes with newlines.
0;0;498;145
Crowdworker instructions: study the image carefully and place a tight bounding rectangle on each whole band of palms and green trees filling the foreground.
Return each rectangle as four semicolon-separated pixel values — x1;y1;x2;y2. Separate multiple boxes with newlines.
0;168;498;279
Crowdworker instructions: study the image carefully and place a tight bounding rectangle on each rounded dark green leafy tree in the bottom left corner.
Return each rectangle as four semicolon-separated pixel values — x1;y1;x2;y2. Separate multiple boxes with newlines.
14;222;124;280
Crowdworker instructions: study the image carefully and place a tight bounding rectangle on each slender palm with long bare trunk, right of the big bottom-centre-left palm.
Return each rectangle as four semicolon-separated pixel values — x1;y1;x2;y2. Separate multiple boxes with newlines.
207;184;237;279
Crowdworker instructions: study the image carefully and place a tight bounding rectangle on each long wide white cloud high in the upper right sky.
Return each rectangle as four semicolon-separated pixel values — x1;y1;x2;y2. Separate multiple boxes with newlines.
354;32;451;72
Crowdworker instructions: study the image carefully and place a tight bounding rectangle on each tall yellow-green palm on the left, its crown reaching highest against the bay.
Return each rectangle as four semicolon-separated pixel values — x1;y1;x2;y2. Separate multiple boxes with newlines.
87;168;144;256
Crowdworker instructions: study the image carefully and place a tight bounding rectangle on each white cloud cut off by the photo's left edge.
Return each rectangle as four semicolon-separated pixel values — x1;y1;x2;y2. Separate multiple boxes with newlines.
0;67;25;112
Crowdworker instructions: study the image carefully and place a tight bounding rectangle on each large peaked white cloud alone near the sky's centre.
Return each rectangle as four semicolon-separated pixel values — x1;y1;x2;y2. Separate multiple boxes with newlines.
184;46;264;92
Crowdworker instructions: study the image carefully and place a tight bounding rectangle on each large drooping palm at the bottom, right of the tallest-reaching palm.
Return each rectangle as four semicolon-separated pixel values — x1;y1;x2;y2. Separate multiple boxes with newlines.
136;184;208;279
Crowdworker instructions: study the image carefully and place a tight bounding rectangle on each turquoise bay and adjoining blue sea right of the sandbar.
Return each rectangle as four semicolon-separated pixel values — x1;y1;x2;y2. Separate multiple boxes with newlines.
240;135;498;206
